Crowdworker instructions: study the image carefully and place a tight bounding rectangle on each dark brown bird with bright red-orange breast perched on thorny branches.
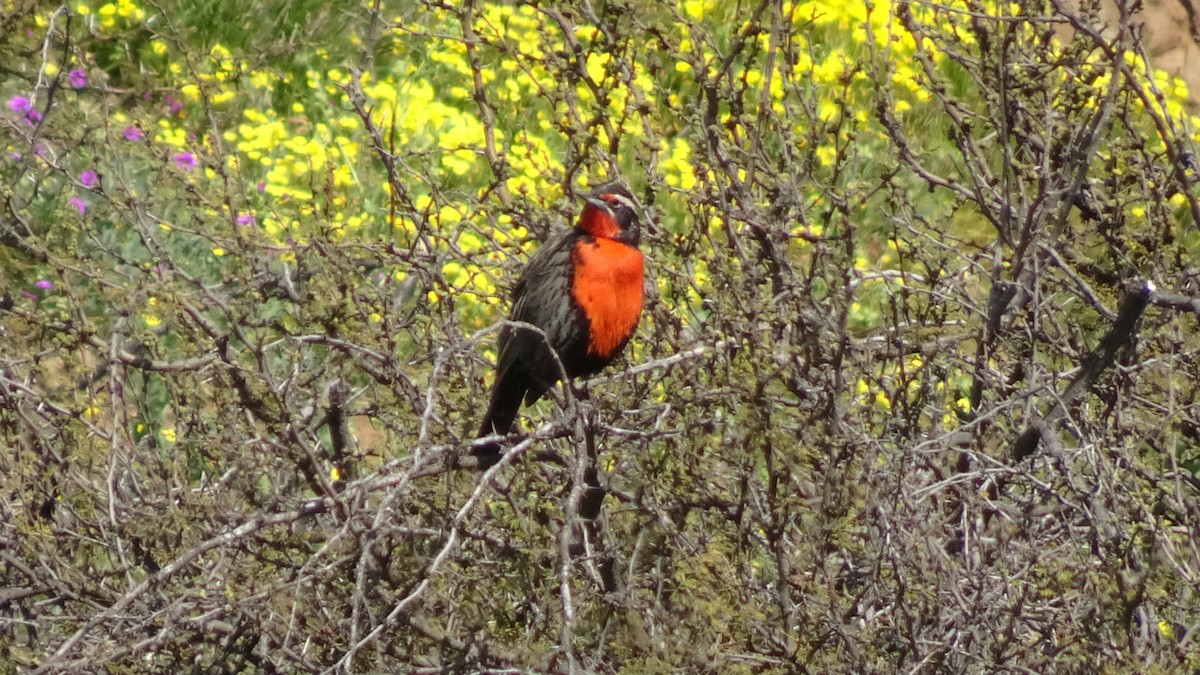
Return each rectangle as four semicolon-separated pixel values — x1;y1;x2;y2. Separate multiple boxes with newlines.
472;184;644;470
